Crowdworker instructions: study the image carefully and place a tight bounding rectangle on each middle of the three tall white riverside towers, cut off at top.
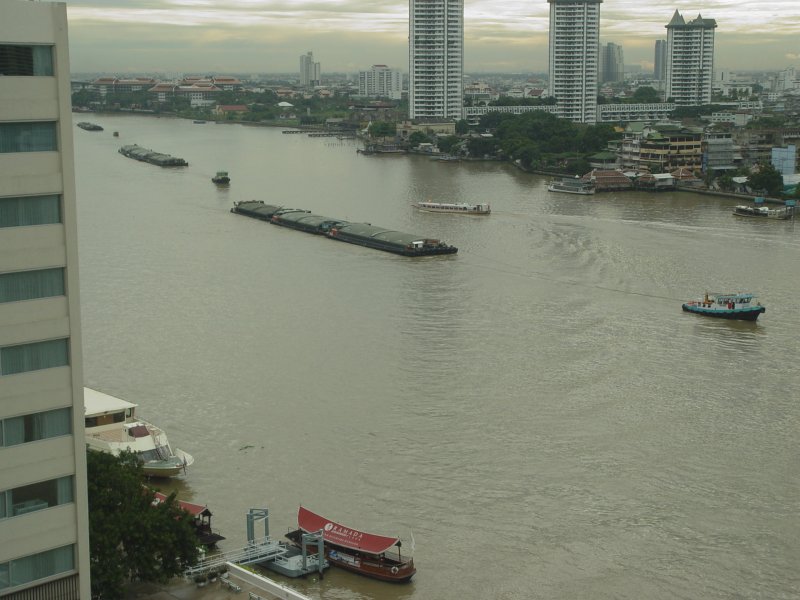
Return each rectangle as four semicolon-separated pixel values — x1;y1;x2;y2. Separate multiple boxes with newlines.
547;0;603;123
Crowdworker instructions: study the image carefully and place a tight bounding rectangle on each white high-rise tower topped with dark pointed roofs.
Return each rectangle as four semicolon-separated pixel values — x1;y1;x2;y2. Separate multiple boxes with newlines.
666;10;717;106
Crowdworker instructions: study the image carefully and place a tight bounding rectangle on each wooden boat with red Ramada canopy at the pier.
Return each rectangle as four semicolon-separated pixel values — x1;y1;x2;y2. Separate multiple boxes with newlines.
286;506;417;583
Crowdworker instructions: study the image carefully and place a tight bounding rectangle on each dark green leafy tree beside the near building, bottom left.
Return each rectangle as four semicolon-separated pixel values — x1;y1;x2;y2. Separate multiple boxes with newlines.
86;450;198;598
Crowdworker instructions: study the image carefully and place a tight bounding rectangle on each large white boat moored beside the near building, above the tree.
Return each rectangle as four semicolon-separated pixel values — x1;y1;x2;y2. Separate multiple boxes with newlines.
83;387;194;477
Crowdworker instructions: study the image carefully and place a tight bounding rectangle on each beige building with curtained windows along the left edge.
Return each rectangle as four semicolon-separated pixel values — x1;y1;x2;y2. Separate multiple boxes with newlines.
0;0;91;600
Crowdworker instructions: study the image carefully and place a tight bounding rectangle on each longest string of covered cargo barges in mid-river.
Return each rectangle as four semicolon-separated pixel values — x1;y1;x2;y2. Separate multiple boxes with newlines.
231;200;458;256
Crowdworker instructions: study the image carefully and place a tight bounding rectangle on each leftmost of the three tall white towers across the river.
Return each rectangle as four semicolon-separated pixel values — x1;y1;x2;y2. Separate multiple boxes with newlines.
408;0;464;121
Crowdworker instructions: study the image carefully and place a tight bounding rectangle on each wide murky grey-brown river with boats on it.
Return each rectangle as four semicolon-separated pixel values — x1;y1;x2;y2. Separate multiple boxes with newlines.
74;115;800;600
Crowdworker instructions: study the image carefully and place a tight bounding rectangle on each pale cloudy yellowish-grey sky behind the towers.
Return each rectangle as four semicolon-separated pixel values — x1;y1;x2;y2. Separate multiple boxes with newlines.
61;0;800;76
